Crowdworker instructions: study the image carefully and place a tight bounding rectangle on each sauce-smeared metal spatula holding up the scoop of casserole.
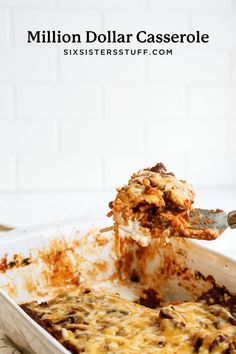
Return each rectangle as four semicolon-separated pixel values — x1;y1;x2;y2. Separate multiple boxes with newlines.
190;209;236;239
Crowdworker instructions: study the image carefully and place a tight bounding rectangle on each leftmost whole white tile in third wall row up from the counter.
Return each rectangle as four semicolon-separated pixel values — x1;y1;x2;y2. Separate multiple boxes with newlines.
16;84;101;120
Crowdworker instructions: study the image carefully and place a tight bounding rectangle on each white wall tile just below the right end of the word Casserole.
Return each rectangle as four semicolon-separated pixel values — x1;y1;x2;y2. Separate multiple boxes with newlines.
148;46;230;85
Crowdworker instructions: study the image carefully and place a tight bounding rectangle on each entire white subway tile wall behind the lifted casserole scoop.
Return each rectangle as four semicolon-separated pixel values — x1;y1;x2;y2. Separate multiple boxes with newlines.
0;0;236;221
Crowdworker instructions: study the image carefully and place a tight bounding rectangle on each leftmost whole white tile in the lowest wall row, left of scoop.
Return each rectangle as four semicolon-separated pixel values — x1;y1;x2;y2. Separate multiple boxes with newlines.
18;156;101;191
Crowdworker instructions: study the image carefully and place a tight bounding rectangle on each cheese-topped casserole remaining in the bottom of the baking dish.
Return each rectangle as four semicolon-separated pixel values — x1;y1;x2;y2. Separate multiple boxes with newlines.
24;291;236;354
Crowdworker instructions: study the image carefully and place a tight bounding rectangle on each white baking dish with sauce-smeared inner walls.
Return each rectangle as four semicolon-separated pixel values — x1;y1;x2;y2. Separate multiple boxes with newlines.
0;220;236;354
